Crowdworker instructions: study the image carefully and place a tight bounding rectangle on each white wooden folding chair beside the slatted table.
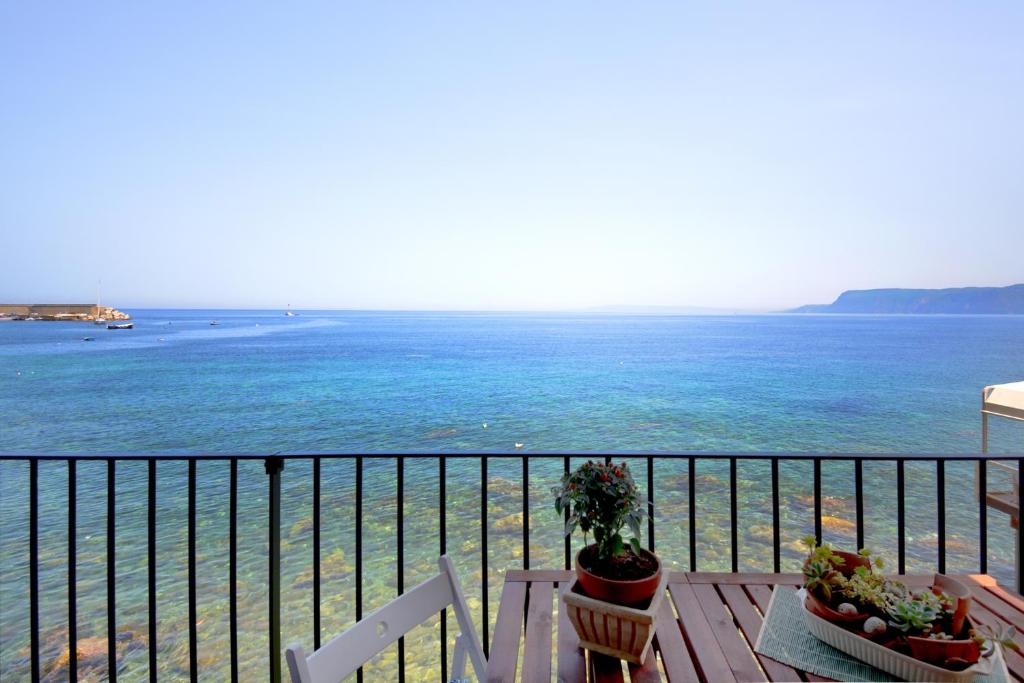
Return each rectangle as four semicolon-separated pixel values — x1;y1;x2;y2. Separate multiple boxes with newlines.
286;555;487;683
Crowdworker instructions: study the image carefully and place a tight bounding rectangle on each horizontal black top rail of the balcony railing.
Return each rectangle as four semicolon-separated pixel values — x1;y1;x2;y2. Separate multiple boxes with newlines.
0;450;1024;462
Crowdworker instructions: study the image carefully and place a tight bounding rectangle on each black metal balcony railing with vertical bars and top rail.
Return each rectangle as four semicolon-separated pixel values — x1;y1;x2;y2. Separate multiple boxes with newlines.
0;453;1024;681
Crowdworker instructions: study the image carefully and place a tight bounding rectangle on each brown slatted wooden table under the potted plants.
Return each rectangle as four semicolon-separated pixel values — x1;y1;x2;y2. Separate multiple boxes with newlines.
486;571;1024;683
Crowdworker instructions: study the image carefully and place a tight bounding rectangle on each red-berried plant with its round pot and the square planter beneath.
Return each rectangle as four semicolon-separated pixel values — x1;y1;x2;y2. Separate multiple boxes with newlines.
552;461;668;664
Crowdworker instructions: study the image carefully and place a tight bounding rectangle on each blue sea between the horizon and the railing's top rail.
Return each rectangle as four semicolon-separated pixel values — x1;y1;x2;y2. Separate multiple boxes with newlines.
6;310;1024;453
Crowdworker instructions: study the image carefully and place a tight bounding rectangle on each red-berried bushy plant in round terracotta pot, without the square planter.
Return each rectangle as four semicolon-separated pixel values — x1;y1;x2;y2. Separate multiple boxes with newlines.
553;461;662;605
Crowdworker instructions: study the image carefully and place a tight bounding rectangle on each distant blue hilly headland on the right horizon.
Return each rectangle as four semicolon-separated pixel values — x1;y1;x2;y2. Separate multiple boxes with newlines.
787;285;1024;314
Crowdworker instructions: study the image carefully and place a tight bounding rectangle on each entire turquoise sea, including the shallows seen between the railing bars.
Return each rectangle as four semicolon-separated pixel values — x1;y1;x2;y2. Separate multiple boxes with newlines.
0;310;1024;680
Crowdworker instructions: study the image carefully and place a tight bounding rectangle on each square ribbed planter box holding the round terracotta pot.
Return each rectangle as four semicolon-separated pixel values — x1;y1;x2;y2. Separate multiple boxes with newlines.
563;571;669;664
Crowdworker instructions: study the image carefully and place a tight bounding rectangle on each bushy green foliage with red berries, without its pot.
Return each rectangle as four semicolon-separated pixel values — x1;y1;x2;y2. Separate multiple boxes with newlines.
552;461;645;573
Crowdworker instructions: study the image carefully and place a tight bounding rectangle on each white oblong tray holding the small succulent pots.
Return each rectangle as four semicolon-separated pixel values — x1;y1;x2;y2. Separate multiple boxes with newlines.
799;590;1010;683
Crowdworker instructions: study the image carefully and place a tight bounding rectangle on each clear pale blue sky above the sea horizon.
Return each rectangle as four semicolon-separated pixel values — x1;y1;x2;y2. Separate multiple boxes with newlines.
0;1;1024;309
